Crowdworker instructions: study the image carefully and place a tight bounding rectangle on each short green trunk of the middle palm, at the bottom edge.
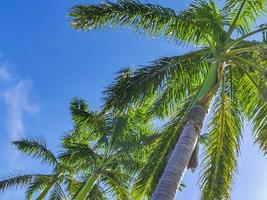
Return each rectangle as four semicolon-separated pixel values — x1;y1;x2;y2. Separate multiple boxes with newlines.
74;173;99;200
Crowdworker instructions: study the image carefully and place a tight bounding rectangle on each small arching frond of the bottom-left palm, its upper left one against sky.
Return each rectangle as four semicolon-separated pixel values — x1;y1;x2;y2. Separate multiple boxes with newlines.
12;138;58;166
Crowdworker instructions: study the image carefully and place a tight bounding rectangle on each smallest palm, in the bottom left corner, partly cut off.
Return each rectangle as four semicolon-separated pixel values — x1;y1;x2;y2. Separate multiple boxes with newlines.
0;138;67;200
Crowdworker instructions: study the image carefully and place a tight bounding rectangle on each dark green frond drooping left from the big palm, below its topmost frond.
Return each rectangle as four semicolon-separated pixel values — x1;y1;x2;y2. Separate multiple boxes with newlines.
104;49;210;110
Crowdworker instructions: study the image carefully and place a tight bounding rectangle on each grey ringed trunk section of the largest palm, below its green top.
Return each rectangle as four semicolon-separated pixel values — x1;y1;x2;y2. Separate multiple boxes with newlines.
152;106;206;200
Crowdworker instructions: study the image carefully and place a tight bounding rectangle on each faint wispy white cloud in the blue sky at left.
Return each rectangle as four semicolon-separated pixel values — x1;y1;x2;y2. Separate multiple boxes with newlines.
0;64;39;171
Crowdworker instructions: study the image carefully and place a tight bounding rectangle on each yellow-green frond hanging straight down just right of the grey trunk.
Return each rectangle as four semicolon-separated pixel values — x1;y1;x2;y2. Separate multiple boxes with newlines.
200;68;243;200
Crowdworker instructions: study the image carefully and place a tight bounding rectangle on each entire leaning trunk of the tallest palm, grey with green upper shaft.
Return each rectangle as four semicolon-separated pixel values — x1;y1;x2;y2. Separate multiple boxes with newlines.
152;63;224;200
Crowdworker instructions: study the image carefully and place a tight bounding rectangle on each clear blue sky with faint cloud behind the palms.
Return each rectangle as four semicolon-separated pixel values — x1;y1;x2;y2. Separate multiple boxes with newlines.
0;0;267;200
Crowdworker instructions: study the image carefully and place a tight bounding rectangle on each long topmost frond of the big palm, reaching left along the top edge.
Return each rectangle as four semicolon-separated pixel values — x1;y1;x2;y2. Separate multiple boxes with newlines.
69;0;216;44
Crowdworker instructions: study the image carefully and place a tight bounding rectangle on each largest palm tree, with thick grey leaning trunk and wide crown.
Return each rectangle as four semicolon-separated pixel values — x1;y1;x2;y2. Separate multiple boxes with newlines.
69;0;267;200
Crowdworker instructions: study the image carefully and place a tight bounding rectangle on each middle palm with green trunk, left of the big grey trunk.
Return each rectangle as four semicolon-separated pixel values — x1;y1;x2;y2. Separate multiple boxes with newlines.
65;99;153;200
